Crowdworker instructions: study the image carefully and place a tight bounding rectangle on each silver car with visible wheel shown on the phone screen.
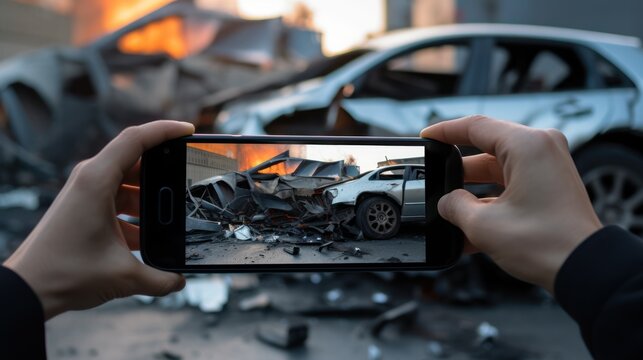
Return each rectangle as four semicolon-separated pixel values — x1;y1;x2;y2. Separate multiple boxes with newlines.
324;164;425;239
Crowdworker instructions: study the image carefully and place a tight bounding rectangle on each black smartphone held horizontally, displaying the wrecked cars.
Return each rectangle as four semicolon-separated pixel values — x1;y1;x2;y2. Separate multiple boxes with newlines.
140;135;463;272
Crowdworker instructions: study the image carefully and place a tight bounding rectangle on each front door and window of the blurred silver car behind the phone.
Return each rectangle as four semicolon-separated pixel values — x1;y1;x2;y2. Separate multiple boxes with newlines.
341;39;480;136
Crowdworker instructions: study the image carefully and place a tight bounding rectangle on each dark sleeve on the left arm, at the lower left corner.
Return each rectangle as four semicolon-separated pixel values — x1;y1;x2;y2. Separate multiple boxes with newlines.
0;266;47;359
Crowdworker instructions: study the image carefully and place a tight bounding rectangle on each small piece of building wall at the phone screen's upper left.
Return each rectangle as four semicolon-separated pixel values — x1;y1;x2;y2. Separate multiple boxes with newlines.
185;147;237;186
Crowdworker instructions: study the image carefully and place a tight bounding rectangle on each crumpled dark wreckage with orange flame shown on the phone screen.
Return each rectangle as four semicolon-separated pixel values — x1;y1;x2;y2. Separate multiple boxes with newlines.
186;151;359;242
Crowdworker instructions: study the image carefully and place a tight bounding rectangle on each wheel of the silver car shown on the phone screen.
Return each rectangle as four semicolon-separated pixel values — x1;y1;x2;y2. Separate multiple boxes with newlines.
357;196;402;239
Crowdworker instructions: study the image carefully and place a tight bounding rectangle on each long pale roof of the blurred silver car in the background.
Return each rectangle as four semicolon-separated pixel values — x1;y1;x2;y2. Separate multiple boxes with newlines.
364;24;641;50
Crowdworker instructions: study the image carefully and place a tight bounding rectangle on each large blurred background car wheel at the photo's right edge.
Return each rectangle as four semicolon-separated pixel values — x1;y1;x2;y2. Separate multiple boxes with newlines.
576;144;643;237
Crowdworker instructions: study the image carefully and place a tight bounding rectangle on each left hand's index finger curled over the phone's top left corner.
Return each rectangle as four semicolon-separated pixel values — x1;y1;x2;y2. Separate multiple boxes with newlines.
96;120;194;180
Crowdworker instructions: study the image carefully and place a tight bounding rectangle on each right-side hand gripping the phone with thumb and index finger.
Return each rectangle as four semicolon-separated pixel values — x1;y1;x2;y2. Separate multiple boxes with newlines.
420;116;602;293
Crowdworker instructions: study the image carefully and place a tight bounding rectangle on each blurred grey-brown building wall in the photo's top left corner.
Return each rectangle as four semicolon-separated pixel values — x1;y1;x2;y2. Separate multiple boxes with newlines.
0;0;72;60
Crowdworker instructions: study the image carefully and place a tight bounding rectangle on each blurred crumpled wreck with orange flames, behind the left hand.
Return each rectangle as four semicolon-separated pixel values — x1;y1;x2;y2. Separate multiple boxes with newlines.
0;0;322;184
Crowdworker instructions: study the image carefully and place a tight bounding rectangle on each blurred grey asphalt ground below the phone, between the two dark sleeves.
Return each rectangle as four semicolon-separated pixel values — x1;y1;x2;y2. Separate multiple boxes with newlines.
46;276;590;360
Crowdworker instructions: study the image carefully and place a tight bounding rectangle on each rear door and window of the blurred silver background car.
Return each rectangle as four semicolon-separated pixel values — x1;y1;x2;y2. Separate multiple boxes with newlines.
482;38;610;148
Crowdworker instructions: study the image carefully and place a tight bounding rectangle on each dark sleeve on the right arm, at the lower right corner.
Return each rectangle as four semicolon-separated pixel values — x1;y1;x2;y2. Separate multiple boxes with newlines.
554;226;643;359
